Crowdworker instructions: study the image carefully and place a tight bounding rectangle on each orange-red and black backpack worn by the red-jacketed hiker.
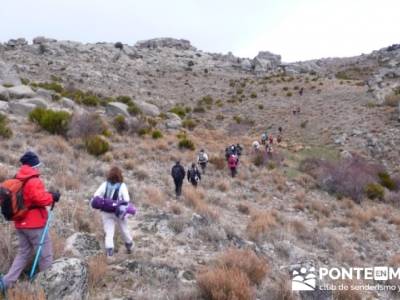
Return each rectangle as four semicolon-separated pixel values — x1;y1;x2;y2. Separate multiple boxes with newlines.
0;176;37;221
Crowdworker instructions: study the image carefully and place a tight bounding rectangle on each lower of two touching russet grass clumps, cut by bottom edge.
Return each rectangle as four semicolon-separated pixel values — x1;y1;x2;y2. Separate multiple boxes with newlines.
197;267;253;300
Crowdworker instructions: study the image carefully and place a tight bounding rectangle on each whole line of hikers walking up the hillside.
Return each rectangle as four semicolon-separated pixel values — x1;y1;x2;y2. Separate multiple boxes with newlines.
0;134;282;294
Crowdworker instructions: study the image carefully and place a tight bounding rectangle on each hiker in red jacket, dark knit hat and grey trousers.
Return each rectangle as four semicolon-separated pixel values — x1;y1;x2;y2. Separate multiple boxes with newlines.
0;151;60;294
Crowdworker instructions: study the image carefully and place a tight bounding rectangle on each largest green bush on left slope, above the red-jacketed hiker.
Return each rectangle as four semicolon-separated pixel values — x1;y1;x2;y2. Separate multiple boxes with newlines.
29;108;71;135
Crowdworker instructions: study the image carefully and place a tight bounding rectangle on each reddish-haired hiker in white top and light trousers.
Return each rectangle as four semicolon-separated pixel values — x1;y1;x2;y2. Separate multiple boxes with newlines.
92;167;133;257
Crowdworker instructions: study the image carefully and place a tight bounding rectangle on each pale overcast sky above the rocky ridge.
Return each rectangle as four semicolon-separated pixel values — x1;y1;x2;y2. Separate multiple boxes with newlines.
0;0;400;62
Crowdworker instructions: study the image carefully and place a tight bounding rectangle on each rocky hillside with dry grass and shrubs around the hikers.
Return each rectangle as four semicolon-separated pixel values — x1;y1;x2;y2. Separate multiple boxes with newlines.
0;38;400;299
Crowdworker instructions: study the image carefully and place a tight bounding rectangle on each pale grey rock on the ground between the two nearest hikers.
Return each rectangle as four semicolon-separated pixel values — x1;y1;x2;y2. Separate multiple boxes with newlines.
65;232;101;258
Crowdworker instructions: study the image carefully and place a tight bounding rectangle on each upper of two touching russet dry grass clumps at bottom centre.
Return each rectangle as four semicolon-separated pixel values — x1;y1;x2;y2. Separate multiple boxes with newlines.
217;248;268;284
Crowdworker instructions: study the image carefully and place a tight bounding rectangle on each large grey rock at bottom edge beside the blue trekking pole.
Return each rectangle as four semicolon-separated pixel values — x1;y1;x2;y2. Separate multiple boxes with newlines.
37;258;88;300
